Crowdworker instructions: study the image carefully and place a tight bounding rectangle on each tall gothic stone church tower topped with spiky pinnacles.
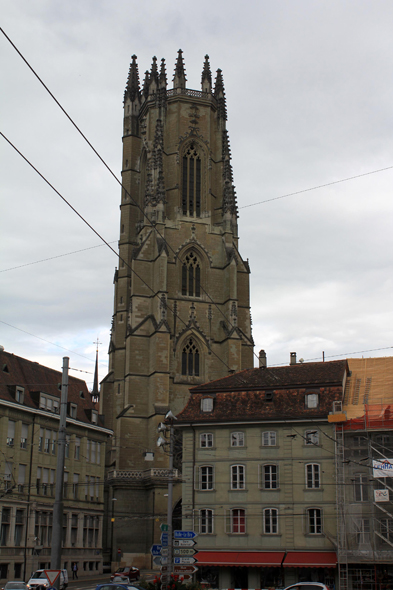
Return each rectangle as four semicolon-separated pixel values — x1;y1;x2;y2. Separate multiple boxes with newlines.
101;50;253;567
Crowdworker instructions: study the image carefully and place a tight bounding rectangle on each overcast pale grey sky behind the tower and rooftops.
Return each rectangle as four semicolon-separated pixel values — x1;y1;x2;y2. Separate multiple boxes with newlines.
0;0;393;386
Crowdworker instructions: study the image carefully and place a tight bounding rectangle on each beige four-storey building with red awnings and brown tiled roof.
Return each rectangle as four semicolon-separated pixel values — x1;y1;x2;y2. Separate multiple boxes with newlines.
176;351;347;588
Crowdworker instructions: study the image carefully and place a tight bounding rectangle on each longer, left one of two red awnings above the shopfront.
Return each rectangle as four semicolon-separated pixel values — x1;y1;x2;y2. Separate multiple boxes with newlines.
195;551;285;567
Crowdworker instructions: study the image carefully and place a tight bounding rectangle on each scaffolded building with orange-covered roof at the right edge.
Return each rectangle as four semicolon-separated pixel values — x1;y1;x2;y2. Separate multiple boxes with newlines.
335;357;393;590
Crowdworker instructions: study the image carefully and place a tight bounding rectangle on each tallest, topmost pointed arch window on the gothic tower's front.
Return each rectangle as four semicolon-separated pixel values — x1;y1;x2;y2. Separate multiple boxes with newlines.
182;143;201;217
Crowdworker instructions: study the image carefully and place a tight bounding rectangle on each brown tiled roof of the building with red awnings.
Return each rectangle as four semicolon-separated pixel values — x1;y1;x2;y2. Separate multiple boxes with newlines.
177;360;347;424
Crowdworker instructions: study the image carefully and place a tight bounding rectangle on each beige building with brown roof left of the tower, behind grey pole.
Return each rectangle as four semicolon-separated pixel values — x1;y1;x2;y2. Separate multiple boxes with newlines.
0;350;112;581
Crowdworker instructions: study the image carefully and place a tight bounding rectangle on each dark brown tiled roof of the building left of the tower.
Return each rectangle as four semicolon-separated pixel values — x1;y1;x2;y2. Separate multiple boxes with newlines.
0;351;102;426
